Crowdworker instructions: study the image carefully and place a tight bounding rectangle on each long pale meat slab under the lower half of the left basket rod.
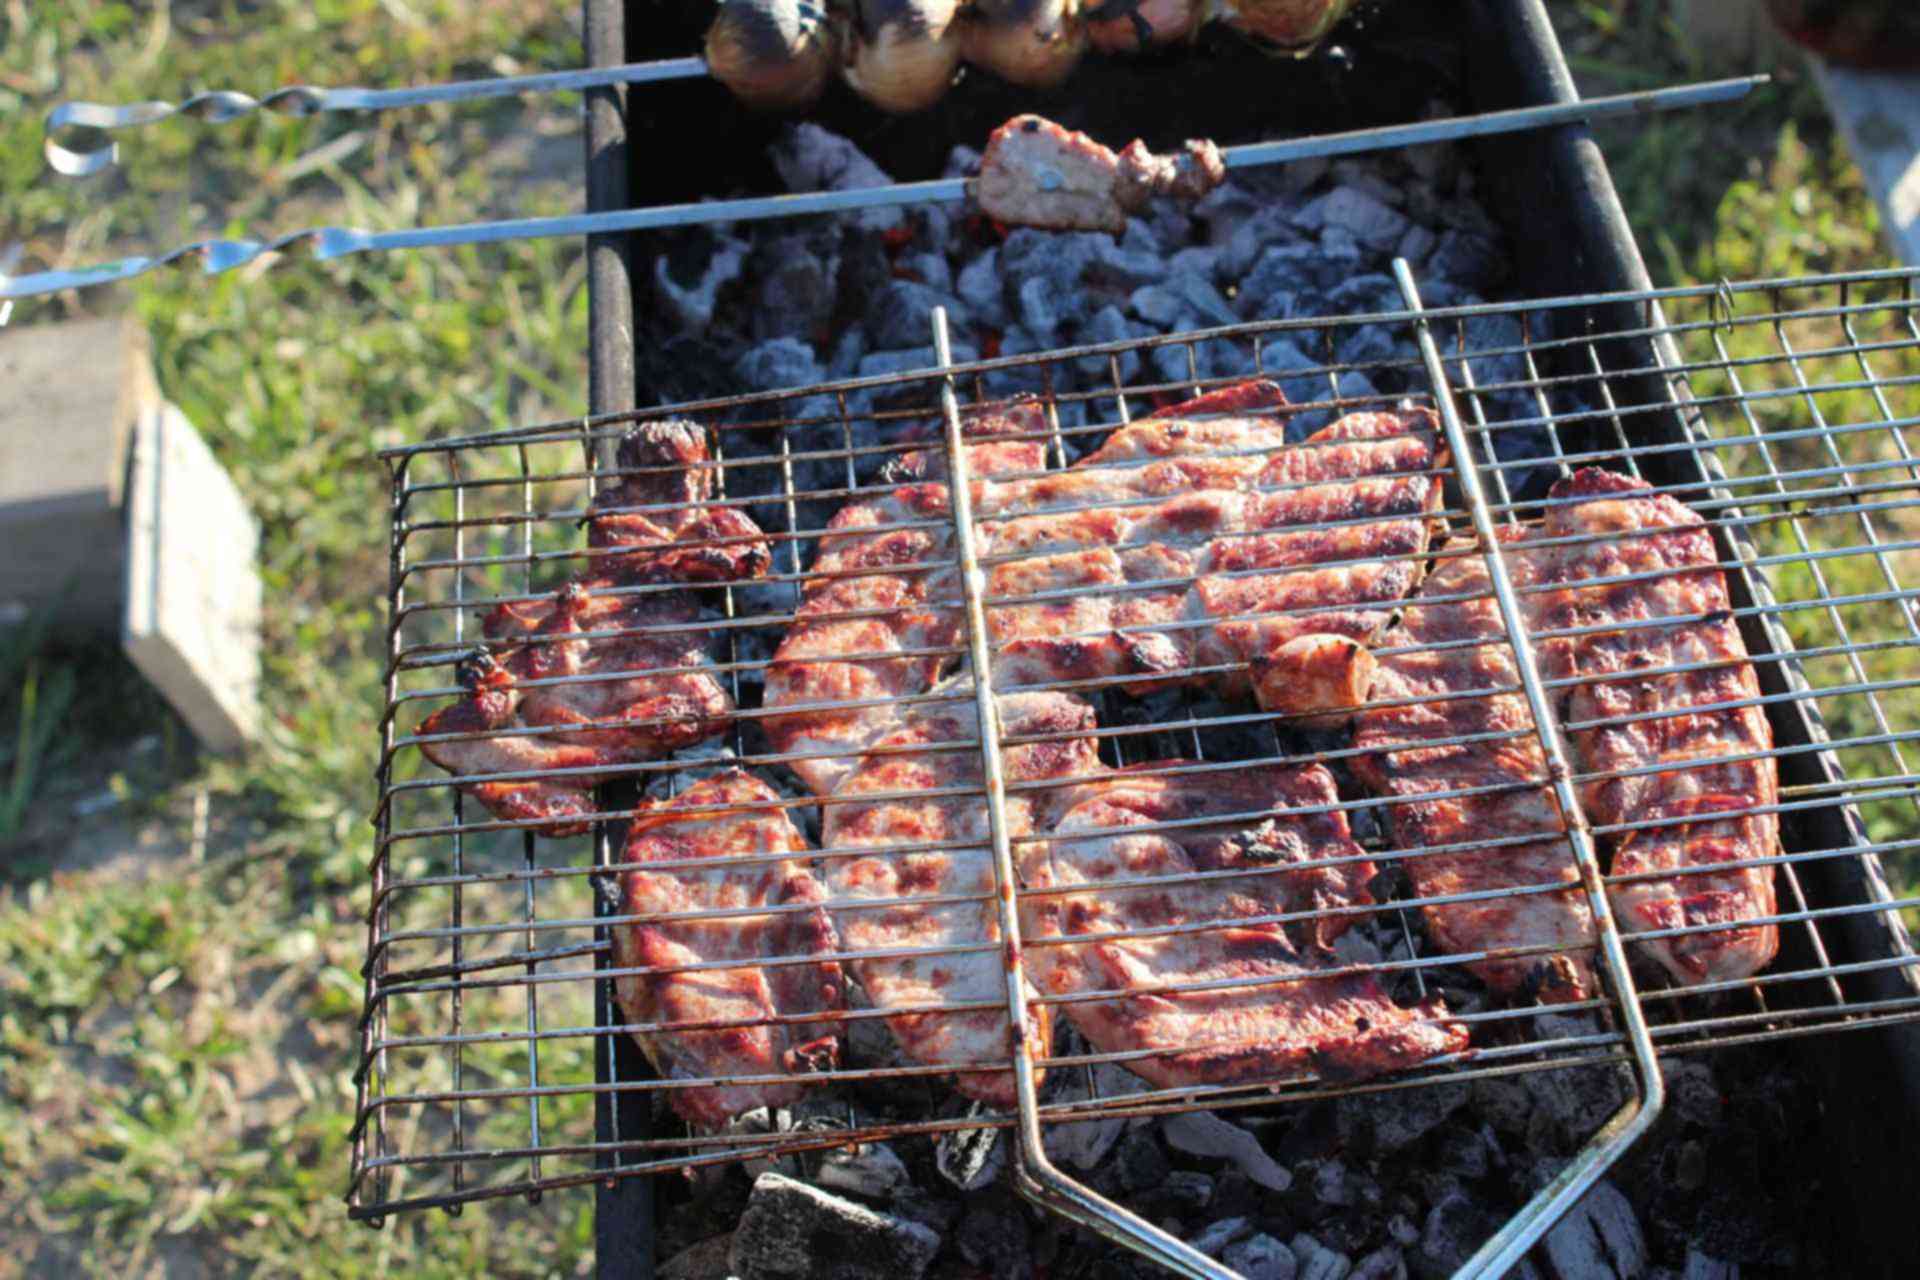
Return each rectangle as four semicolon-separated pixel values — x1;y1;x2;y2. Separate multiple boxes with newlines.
822;676;1102;1107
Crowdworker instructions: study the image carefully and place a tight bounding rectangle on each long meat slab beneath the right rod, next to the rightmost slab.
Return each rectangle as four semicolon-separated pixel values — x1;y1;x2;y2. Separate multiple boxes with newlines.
1354;526;1596;1002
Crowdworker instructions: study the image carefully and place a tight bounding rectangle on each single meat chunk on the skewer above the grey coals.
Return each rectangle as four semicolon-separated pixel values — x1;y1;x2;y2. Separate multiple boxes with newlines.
973;115;1227;236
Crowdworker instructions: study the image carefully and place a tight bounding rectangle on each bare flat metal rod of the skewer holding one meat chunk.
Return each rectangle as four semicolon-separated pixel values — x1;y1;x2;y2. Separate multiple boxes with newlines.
0;75;1768;299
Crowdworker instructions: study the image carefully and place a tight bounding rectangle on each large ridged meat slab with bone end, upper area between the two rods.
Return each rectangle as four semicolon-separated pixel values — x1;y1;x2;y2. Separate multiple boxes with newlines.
975;401;1444;706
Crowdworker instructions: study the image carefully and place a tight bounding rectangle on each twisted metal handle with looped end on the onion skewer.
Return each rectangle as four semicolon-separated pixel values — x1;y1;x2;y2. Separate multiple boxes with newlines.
40;58;707;178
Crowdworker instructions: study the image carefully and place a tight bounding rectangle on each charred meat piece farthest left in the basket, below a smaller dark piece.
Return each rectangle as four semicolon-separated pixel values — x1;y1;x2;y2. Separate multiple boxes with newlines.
419;580;733;837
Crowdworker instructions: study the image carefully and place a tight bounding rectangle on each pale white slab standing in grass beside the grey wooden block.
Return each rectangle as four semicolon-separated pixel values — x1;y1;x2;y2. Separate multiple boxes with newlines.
121;405;261;750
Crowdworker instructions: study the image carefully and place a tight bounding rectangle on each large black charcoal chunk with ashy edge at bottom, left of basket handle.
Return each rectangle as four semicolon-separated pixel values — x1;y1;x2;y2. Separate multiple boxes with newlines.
732;1173;941;1280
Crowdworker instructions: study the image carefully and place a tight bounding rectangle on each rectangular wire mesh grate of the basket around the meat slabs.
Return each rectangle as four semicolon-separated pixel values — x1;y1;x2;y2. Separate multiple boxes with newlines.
349;273;1920;1258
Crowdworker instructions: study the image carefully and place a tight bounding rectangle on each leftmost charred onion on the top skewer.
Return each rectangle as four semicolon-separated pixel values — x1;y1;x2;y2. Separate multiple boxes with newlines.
707;0;841;111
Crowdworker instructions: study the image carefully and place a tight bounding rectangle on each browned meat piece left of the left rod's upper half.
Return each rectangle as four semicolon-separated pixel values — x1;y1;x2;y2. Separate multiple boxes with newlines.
764;405;1046;794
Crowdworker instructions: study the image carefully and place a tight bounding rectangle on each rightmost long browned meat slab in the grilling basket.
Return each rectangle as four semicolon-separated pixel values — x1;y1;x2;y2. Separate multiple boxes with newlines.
1542;468;1780;984
